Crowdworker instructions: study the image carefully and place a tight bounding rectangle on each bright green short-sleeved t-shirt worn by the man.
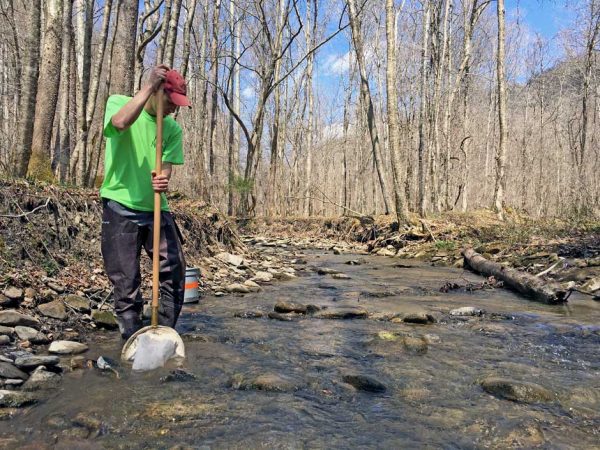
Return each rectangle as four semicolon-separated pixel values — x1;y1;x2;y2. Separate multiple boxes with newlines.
100;95;183;211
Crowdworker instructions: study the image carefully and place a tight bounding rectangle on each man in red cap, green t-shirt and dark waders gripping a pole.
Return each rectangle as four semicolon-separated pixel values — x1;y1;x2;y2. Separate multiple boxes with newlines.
100;65;191;339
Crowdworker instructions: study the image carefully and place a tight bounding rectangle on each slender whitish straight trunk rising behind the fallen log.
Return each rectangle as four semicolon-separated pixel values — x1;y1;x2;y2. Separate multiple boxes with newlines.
494;0;507;220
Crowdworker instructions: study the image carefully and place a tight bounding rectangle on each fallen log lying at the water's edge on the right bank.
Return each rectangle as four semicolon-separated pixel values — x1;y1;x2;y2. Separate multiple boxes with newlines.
462;248;569;305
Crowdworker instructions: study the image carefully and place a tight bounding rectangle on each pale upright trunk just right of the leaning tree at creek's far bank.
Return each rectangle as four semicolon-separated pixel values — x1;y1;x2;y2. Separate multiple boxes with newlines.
385;0;408;225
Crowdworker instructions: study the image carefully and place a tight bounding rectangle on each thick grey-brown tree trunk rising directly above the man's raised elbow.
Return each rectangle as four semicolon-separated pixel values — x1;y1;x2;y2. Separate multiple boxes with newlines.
110;0;138;95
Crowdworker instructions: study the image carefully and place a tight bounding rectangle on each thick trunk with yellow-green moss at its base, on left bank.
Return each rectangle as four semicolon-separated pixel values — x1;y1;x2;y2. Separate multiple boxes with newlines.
27;0;63;180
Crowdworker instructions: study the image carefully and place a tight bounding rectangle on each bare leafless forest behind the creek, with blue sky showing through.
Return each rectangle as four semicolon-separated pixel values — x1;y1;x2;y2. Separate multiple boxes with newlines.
0;0;600;222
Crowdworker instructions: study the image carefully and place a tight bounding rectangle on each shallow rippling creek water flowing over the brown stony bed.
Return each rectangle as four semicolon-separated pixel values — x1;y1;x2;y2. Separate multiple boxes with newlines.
0;253;600;449
